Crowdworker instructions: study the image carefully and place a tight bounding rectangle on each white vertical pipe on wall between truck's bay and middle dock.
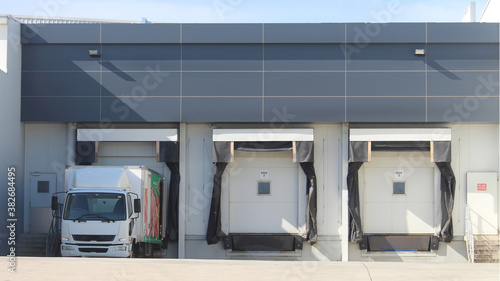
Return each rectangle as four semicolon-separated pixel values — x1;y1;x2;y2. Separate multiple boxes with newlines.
178;123;188;259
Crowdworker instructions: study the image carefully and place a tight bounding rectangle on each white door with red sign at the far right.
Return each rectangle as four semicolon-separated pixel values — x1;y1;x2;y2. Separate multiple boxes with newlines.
467;172;499;235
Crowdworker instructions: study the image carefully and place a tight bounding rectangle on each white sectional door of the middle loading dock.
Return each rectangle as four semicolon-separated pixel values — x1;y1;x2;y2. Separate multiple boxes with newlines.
229;151;300;233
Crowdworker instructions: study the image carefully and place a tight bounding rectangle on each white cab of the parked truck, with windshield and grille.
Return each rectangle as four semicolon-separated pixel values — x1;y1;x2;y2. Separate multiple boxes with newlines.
61;189;138;257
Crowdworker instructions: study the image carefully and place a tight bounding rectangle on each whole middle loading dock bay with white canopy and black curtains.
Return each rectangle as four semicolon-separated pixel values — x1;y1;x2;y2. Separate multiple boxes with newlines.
207;129;317;252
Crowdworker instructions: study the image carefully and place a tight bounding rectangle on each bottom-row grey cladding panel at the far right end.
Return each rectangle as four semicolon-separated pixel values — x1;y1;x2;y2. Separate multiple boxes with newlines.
427;97;499;122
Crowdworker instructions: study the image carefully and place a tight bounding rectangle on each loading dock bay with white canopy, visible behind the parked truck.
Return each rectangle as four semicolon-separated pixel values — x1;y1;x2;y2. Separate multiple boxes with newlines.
76;128;180;241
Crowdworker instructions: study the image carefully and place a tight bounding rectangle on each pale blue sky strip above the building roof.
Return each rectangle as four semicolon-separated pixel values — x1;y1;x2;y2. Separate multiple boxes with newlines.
0;0;488;23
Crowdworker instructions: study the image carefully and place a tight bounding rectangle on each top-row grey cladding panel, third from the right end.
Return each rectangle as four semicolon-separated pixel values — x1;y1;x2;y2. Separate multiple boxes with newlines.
264;23;345;43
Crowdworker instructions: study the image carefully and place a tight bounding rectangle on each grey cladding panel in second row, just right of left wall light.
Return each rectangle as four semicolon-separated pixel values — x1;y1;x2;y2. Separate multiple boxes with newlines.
102;44;181;72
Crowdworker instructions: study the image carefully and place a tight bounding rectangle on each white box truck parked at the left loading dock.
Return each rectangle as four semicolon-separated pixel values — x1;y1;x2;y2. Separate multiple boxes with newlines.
52;166;166;257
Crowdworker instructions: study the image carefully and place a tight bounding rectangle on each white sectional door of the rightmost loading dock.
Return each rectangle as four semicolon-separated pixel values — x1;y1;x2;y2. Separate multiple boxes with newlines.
359;152;436;234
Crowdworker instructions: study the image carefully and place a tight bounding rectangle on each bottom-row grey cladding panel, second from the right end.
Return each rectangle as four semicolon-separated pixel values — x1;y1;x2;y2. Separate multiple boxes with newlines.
347;97;425;122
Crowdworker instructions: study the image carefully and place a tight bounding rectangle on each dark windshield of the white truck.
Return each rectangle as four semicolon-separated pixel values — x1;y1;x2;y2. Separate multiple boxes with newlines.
63;193;126;221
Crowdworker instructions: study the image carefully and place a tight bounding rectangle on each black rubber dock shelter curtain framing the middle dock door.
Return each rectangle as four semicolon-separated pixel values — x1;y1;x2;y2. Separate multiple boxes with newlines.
206;141;317;244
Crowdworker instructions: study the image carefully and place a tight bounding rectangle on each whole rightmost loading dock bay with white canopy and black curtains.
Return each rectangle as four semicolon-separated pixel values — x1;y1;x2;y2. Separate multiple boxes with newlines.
347;128;455;251
